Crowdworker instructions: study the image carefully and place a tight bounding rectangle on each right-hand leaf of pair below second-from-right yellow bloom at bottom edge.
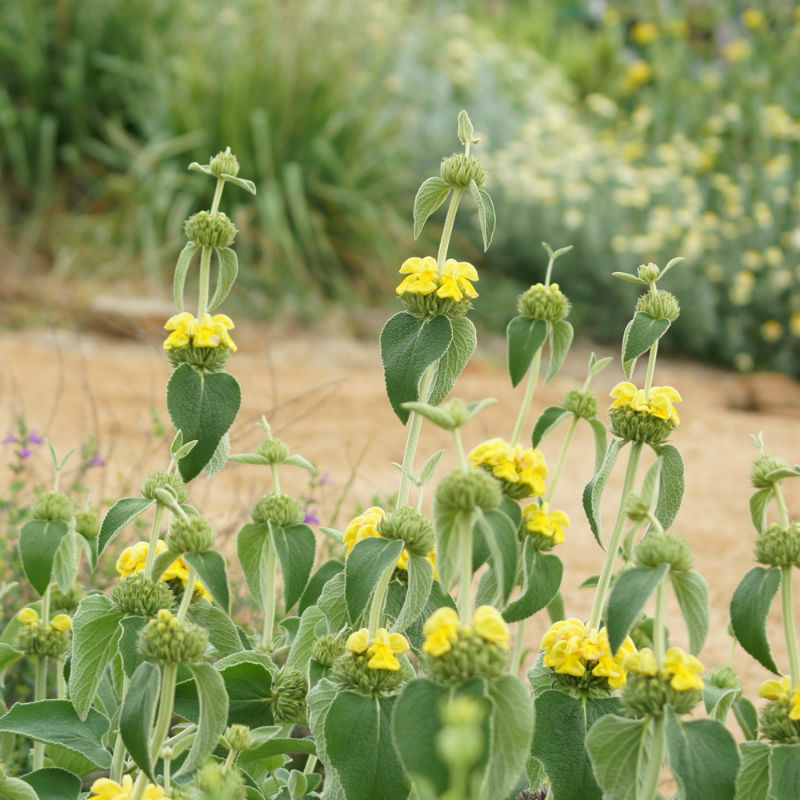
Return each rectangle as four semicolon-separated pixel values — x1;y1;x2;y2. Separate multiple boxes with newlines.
664;706;739;800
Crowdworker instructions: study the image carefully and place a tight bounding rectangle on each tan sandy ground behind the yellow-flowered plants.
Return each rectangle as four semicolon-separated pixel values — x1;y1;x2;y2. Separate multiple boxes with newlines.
0;320;800;712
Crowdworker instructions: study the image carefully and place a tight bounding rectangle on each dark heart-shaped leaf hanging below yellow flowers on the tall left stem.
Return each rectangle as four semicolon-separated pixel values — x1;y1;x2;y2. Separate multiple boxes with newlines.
167;364;242;483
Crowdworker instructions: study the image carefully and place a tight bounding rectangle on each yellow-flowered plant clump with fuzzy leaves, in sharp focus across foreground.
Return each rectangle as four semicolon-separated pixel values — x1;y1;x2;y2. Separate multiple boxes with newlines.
0;109;800;800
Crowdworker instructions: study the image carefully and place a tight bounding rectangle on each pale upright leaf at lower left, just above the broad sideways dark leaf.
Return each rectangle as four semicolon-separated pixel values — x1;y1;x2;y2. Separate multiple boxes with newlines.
69;594;124;720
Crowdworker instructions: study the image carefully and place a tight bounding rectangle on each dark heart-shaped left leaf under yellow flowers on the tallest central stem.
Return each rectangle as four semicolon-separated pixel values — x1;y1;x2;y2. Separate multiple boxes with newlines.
381;311;453;425
